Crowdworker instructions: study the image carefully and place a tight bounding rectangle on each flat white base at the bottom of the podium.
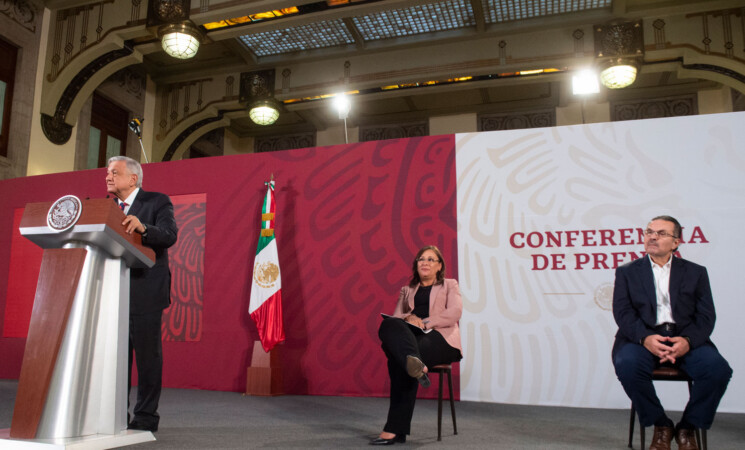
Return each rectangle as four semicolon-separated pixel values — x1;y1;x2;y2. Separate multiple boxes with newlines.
0;428;155;450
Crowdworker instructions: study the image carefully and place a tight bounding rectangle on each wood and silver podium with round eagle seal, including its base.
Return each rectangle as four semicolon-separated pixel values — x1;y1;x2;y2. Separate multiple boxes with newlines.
0;196;155;448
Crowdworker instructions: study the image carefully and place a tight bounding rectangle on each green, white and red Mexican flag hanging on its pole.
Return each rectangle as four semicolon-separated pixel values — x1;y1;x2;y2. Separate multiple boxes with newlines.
248;180;285;353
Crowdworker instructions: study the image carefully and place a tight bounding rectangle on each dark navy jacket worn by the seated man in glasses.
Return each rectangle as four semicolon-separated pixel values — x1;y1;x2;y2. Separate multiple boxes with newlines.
613;256;716;355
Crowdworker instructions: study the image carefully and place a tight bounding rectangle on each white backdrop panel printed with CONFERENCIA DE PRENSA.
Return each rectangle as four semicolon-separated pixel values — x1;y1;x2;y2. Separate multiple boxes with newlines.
456;113;745;412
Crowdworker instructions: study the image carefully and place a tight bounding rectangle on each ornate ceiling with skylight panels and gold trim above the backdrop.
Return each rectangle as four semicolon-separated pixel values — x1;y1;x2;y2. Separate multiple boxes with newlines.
39;0;745;150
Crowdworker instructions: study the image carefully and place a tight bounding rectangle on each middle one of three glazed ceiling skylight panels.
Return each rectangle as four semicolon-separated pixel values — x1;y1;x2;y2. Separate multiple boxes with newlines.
352;0;476;41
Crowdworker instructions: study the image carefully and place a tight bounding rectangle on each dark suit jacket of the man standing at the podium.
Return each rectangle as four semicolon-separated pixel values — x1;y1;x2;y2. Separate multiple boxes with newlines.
127;188;178;315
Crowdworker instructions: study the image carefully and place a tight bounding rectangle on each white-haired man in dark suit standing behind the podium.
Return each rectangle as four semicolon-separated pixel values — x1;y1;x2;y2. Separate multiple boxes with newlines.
106;156;178;431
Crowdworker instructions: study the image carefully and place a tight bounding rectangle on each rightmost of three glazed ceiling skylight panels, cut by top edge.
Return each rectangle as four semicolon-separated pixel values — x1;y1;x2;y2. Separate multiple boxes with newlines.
481;0;612;23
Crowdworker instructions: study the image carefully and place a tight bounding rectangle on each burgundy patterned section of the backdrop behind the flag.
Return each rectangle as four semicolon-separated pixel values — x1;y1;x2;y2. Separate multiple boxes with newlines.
0;135;458;396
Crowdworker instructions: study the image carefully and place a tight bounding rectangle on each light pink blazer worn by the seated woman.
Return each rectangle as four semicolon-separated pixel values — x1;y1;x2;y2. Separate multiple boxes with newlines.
393;278;463;351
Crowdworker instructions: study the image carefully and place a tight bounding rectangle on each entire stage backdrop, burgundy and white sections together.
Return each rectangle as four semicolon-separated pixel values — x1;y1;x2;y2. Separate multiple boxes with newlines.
0;113;745;412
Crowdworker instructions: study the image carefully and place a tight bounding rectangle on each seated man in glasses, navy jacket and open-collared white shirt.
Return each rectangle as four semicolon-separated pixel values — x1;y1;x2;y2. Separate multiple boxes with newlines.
612;216;732;450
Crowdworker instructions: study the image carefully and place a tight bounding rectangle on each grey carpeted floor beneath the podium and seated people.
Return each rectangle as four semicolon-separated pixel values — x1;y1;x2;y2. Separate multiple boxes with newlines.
0;380;745;450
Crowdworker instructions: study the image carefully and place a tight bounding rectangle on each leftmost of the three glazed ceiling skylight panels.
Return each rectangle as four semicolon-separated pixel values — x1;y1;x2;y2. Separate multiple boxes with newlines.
239;20;354;56
